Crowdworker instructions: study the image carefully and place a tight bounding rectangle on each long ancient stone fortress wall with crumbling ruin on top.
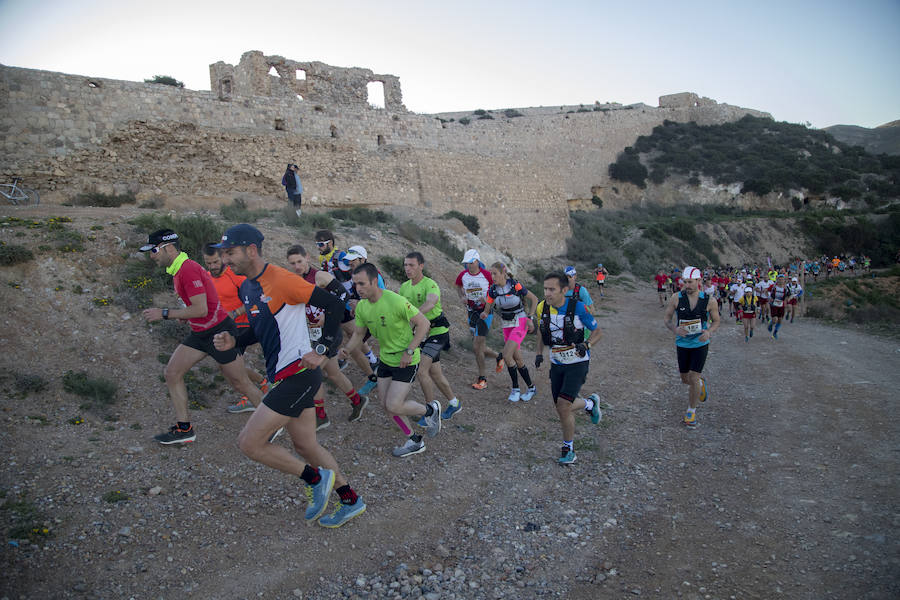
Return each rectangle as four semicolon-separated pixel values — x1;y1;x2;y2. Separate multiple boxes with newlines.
0;52;763;259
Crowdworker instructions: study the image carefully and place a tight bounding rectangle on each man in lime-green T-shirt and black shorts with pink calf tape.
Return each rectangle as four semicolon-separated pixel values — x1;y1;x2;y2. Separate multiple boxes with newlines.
341;263;441;457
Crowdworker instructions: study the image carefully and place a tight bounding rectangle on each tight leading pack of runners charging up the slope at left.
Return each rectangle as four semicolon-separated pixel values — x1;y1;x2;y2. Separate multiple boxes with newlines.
140;224;608;527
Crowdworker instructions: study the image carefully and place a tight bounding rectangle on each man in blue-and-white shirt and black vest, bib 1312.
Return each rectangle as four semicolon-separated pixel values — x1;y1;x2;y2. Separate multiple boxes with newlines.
534;273;602;465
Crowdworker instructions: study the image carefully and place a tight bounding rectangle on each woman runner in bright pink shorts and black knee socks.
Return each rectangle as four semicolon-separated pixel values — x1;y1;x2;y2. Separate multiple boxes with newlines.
481;262;537;402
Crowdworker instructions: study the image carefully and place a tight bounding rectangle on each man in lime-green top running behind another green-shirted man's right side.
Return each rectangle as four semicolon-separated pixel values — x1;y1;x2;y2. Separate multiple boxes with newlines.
400;252;462;426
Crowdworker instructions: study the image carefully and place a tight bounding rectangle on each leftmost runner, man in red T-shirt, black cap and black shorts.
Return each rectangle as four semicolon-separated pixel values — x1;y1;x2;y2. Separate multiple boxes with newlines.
141;229;262;444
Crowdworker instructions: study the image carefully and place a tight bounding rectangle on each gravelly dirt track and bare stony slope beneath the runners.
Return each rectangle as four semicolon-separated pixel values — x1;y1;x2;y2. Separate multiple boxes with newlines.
0;207;900;600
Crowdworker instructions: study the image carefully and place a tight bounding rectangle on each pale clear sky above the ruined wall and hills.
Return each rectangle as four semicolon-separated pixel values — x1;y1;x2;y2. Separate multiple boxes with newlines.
0;0;900;127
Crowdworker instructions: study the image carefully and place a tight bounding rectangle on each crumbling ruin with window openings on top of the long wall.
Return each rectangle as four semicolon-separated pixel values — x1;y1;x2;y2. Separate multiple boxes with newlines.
209;50;407;112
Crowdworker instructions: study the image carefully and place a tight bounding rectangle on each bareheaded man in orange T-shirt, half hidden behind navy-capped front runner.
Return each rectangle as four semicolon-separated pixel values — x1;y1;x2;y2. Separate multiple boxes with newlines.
203;244;269;414
